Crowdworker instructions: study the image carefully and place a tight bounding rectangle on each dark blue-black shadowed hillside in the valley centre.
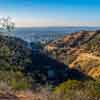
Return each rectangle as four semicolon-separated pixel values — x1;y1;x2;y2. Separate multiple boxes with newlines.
30;50;86;84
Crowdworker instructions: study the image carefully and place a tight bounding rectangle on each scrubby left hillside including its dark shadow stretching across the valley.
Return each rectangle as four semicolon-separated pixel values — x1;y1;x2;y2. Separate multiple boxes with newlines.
0;36;87;89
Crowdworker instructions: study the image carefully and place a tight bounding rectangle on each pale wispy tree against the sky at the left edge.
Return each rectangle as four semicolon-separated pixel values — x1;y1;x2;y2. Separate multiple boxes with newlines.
0;17;15;32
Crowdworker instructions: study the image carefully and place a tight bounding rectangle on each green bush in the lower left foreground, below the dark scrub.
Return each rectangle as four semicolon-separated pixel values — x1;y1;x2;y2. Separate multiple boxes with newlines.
0;71;32;90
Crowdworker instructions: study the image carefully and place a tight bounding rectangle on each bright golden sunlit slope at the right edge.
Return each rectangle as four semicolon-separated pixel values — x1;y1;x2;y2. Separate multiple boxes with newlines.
69;53;100;79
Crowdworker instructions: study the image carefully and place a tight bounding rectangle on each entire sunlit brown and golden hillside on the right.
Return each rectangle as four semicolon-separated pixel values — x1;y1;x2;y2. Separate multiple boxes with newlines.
45;31;100;79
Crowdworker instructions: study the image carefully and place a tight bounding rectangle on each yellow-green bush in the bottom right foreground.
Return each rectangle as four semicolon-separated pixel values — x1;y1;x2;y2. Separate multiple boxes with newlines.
53;80;100;100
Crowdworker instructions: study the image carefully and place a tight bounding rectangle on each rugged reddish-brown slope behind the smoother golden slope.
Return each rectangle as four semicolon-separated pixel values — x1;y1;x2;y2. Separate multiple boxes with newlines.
45;31;99;64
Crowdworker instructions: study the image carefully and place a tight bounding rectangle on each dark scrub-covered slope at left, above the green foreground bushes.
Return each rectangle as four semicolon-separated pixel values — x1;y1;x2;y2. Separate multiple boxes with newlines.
0;36;32;67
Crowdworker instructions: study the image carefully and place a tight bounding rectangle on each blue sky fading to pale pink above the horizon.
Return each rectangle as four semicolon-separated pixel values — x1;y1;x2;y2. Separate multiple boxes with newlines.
0;0;100;27
